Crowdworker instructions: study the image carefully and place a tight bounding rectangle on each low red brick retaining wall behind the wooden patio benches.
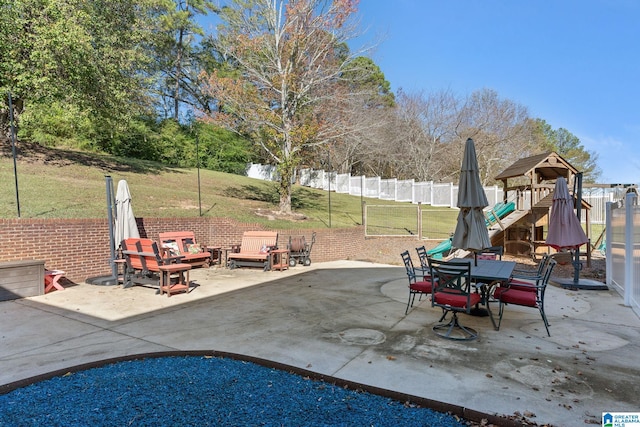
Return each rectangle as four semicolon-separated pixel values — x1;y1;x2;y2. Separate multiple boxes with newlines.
0;217;365;283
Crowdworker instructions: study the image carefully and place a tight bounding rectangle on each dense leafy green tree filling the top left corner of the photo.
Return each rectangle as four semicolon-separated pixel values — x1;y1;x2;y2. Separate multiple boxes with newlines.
0;0;160;140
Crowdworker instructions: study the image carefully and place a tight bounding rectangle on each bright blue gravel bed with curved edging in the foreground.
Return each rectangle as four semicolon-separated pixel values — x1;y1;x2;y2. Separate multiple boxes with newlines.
0;357;466;427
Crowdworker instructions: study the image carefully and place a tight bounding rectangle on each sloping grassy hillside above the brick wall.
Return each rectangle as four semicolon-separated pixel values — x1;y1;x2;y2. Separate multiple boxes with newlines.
0;143;450;228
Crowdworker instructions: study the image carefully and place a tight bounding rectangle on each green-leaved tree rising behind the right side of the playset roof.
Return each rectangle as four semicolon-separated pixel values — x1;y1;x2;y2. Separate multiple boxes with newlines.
534;119;602;182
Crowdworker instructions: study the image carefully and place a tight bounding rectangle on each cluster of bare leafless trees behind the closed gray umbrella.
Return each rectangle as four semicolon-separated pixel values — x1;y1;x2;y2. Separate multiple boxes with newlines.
369;89;533;184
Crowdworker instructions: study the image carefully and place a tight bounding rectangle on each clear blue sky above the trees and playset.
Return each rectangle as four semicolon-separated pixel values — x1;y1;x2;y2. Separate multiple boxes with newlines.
359;0;640;183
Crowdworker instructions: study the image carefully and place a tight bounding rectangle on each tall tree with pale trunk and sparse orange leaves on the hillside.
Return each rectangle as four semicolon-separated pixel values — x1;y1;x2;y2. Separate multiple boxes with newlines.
200;0;370;213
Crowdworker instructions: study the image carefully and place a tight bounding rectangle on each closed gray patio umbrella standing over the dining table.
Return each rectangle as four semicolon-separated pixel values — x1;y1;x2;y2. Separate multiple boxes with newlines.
451;138;491;251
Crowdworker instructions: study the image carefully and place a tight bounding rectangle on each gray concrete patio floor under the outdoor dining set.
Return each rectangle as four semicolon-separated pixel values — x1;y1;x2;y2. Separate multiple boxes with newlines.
0;261;640;426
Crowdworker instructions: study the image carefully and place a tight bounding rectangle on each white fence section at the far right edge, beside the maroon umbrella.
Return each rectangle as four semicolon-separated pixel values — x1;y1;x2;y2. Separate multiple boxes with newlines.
606;193;640;316
